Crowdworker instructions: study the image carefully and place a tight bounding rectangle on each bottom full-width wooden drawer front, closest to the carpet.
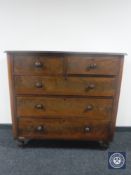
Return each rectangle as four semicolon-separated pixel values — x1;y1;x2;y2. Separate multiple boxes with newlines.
18;118;110;140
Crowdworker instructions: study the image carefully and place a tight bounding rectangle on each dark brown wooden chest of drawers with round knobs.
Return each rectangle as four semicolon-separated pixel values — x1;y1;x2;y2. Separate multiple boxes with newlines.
7;51;124;146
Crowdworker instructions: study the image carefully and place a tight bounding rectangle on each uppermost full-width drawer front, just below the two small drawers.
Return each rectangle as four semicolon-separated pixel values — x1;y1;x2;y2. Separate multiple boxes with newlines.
15;76;116;96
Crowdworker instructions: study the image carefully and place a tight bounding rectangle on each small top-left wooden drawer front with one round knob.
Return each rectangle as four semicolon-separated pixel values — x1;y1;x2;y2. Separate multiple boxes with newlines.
14;55;63;75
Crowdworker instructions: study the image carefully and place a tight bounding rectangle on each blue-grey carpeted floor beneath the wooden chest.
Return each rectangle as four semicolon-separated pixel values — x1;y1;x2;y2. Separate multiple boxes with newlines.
0;128;131;175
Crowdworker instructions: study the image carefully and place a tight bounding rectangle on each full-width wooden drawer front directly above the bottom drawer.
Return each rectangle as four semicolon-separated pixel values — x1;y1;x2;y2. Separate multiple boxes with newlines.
17;97;112;120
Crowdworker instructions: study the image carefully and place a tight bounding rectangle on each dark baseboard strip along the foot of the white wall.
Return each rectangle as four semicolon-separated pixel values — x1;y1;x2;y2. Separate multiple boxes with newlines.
0;124;131;132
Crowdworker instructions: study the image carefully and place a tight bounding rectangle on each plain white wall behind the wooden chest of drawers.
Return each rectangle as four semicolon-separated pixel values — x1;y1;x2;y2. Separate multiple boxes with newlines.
0;0;131;126
